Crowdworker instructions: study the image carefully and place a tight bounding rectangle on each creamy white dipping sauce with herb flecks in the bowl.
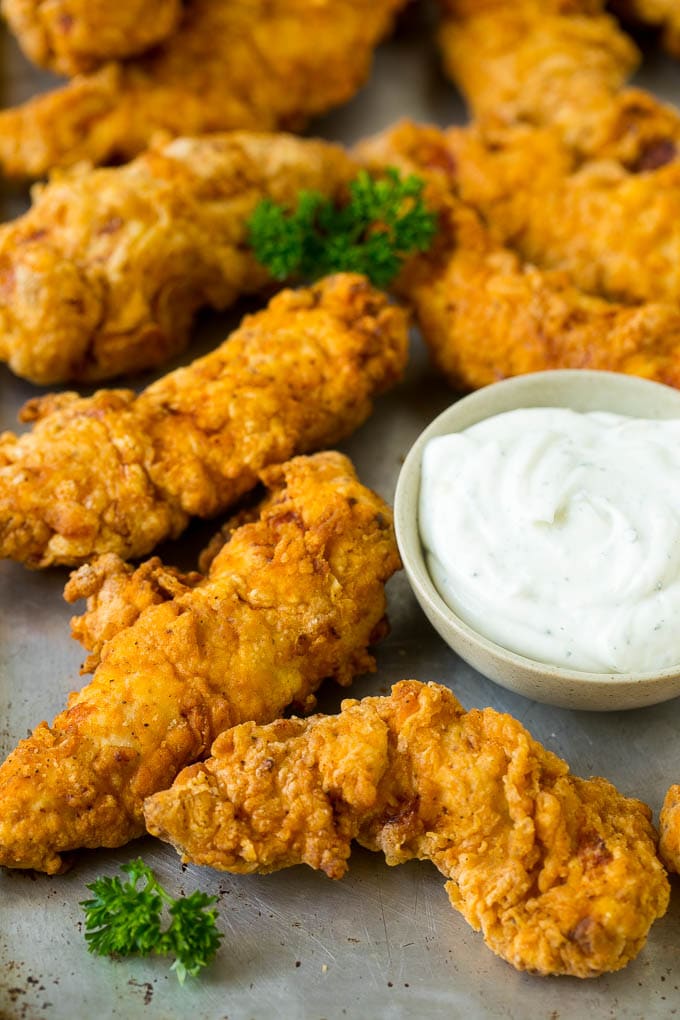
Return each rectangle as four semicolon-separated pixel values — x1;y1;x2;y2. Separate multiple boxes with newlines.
420;407;680;673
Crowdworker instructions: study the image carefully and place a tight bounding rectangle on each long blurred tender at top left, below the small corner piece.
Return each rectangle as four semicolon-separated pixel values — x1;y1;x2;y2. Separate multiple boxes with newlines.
0;0;404;176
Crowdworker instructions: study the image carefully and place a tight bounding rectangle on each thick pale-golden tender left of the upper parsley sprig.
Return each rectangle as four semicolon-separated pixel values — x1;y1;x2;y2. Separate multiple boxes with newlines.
0;133;356;384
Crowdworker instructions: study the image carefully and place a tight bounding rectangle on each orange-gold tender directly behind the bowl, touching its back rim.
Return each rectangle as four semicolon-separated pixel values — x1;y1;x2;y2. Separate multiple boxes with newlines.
357;122;680;390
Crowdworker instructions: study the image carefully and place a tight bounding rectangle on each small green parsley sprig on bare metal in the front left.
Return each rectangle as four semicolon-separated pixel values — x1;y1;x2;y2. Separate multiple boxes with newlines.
81;858;222;984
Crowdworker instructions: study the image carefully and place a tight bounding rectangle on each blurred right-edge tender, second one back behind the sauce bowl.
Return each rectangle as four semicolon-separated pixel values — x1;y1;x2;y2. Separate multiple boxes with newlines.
446;126;680;305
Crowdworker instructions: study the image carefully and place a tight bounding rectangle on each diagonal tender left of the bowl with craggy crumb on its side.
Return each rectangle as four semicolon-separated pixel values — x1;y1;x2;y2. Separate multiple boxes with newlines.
0;453;400;874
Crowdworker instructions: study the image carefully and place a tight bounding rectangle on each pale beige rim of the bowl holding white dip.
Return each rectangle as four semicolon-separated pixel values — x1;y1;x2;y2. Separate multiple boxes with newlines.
395;368;680;694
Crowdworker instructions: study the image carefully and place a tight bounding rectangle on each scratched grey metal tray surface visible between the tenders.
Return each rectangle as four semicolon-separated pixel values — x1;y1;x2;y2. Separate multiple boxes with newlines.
0;7;680;1020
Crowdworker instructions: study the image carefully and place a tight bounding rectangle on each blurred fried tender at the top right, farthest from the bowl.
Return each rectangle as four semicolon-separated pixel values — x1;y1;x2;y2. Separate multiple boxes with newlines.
440;0;680;168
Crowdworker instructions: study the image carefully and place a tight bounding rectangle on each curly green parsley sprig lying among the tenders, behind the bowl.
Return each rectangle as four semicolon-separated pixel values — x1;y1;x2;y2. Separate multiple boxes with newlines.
248;167;437;287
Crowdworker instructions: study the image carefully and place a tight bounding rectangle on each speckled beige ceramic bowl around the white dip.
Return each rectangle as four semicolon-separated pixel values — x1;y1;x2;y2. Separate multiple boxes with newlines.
395;370;680;711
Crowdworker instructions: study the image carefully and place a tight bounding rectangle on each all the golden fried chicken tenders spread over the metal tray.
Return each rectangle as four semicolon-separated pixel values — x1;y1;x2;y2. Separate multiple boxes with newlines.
0;0;680;977
